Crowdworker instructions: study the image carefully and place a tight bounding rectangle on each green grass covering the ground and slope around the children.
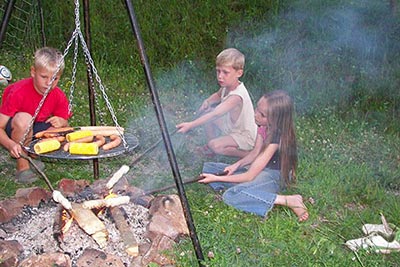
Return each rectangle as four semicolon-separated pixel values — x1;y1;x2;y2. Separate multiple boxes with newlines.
0;0;400;267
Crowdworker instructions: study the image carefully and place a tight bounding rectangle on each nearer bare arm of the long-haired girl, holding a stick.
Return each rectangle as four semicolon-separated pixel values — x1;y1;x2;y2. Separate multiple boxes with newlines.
199;144;279;183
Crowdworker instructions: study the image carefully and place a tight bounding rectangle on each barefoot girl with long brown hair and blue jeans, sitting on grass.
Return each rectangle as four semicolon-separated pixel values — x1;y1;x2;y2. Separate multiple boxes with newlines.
199;90;308;222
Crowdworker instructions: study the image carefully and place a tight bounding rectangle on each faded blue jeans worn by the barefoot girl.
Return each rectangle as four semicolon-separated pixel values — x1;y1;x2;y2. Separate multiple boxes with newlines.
203;162;281;216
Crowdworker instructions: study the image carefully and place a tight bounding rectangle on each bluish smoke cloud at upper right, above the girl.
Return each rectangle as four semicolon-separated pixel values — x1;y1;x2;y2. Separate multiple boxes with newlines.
227;0;400;112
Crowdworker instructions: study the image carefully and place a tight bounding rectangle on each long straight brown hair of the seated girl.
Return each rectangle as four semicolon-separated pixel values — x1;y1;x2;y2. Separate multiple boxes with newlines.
263;90;297;186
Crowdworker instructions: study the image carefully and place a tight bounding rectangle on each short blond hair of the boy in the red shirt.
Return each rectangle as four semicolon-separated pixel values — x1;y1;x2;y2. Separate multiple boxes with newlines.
34;47;65;73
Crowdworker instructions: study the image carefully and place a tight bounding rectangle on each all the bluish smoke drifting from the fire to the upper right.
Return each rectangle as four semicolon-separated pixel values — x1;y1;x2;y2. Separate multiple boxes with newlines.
125;0;400;191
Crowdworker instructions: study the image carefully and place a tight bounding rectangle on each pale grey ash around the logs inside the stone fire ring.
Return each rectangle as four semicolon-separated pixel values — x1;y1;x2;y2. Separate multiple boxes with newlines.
0;203;149;266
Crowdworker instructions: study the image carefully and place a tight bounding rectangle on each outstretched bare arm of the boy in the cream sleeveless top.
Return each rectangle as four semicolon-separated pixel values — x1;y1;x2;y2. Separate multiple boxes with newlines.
176;95;242;133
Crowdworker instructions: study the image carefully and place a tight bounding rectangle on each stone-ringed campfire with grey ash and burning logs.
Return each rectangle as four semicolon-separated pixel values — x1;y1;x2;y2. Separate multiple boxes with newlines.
0;166;188;267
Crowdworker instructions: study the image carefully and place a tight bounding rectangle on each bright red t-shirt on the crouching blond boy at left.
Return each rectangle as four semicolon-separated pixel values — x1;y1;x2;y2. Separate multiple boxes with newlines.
0;78;72;122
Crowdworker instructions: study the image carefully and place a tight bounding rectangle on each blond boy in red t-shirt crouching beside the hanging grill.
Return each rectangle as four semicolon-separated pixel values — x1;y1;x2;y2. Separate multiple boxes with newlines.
0;47;72;183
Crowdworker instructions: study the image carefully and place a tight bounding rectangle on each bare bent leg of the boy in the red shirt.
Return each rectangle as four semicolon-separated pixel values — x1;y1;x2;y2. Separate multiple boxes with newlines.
11;112;32;171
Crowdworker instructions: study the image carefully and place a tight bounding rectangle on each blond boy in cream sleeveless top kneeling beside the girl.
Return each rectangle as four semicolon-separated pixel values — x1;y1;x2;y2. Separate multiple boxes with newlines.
176;48;257;158
